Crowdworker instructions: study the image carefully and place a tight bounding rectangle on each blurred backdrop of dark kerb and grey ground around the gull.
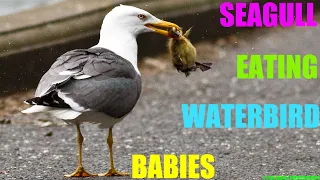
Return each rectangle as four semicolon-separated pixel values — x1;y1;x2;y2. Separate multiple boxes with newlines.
0;0;320;180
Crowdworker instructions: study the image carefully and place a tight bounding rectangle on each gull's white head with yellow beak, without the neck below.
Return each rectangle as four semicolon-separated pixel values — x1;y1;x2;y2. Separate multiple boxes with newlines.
102;5;181;37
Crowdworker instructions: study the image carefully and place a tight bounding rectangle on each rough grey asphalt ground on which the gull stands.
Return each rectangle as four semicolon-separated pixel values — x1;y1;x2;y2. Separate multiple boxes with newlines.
0;27;320;180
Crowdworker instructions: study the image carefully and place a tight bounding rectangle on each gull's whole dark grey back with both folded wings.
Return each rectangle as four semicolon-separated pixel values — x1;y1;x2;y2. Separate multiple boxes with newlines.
35;48;141;118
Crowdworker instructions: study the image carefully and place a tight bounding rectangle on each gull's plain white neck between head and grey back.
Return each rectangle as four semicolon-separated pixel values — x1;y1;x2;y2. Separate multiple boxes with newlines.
94;24;140;75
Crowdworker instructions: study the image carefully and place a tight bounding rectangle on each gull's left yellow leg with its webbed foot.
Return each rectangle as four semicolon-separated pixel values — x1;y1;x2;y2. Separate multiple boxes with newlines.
65;124;96;177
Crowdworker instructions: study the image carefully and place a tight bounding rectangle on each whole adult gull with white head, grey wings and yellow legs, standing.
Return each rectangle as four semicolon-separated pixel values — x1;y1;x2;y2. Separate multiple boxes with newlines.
22;5;181;177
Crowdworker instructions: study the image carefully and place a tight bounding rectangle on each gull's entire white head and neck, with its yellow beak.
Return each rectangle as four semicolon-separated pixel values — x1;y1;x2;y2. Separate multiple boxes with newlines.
94;5;181;74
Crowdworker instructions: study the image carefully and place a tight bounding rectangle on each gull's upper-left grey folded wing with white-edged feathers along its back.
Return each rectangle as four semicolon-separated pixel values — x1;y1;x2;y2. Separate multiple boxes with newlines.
35;48;117;97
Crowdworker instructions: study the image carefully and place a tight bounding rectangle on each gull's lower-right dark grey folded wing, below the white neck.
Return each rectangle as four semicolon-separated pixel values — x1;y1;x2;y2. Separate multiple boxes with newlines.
60;74;141;118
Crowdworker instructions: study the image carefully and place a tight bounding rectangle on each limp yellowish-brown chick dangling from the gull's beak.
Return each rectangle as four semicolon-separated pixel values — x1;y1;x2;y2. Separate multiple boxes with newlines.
168;27;212;77
